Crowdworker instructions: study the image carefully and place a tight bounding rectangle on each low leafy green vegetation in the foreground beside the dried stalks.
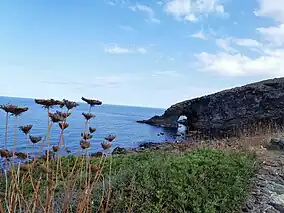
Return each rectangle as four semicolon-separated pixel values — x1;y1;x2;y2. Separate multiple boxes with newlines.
0;149;255;213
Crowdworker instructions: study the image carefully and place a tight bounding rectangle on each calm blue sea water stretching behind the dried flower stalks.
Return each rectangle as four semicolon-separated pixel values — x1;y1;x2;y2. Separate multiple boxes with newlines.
0;97;184;153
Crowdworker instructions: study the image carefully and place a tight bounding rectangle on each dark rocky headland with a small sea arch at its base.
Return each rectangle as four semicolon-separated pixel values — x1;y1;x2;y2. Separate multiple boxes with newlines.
138;78;284;137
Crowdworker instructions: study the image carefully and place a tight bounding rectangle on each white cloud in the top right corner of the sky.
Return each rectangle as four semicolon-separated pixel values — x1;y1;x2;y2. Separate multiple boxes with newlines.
254;0;284;23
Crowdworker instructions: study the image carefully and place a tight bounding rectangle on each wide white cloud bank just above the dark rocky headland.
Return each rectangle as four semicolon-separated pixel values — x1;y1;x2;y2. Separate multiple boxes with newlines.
196;50;284;77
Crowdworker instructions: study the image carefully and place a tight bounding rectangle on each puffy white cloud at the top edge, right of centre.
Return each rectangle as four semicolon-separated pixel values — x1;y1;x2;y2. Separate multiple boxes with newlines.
164;0;229;22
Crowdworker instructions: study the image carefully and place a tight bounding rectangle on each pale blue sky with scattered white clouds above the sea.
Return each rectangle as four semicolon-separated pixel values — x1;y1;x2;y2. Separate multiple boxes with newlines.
0;0;284;108
